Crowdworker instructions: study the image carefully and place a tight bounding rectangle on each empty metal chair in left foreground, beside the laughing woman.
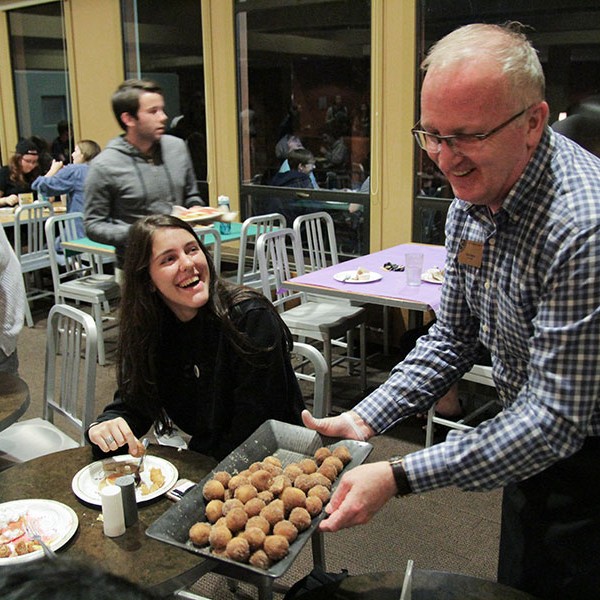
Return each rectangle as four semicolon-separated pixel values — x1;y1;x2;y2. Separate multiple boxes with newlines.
0;304;98;462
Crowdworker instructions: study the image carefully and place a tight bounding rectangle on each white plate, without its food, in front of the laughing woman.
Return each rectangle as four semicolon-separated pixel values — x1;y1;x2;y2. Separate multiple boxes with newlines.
71;454;178;506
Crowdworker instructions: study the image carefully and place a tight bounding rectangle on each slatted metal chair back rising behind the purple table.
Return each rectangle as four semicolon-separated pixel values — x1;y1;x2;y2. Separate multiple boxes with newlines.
293;212;338;271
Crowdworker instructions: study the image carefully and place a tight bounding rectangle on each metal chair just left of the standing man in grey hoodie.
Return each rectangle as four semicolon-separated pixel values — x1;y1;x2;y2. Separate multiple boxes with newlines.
46;213;121;365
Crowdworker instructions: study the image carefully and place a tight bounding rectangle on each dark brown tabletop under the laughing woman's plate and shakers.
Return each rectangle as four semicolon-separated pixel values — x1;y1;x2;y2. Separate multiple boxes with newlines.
0;445;217;596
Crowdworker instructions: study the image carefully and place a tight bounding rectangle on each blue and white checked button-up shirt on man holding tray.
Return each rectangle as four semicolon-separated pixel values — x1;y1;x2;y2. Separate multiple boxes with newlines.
354;129;600;492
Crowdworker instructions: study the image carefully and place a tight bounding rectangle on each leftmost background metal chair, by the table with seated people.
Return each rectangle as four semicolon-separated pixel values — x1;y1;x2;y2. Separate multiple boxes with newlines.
14;200;54;327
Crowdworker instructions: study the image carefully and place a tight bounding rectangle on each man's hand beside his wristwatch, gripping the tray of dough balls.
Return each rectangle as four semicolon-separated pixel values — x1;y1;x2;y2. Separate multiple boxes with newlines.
319;461;397;531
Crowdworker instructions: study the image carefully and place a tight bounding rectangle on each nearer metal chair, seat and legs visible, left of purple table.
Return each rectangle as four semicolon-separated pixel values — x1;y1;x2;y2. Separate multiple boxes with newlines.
257;228;367;414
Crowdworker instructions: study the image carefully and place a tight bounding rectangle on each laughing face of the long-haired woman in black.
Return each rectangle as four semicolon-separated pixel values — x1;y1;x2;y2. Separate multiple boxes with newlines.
149;228;210;321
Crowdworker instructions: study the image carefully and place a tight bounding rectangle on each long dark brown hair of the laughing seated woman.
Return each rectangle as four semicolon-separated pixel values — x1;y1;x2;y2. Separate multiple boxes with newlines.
117;215;293;428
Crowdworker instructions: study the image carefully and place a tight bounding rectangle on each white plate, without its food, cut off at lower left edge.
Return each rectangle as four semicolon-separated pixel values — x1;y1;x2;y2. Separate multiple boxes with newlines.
0;499;79;566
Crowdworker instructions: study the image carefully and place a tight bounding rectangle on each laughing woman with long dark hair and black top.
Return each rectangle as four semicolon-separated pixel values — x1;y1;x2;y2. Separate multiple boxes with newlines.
88;215;304;460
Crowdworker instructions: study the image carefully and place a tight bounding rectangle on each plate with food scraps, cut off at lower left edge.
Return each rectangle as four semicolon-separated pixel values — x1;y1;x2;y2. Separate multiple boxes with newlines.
0;498;79;568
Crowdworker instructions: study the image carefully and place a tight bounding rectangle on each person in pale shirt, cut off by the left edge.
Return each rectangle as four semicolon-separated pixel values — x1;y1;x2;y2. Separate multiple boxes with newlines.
0;227;26;375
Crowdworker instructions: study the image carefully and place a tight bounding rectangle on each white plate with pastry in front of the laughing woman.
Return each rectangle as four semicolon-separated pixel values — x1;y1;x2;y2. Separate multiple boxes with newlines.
71;454;179;506
